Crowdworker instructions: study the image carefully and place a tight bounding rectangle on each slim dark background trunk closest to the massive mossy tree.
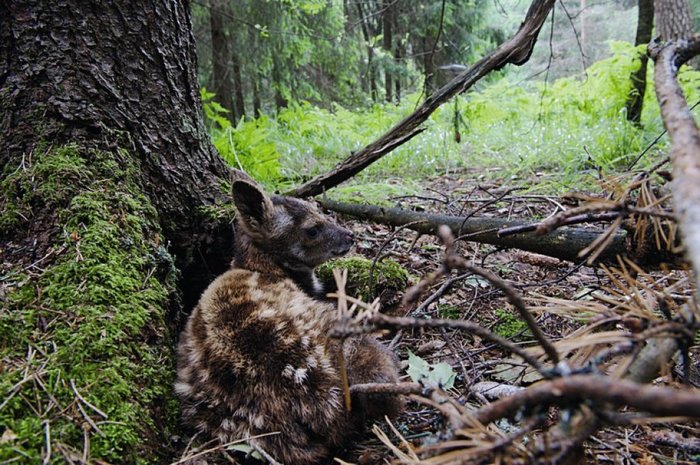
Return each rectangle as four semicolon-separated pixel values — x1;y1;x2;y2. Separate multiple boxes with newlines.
209;0;240;121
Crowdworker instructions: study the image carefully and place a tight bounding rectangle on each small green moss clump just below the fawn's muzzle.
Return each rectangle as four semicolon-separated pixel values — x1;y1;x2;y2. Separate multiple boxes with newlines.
316;257;409;301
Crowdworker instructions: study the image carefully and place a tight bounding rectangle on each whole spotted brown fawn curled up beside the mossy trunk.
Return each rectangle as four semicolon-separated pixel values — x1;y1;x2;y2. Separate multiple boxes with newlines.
175;176;399;465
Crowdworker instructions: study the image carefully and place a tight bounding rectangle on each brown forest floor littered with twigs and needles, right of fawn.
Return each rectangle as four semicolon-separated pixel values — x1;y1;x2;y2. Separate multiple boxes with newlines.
334;172;700;464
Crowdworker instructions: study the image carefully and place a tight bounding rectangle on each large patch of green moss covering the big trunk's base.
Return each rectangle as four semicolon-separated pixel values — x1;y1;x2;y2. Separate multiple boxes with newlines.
0;145;177;463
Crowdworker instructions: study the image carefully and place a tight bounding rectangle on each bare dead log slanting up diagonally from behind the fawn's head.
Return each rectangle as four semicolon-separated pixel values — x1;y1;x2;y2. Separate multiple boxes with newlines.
287;0;554;197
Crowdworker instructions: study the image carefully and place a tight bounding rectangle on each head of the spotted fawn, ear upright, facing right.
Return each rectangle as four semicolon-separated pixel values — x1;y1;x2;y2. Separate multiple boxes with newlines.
232;180;354;274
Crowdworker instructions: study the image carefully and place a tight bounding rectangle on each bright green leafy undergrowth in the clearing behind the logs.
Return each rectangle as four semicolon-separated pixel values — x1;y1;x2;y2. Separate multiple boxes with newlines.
204;42;700;203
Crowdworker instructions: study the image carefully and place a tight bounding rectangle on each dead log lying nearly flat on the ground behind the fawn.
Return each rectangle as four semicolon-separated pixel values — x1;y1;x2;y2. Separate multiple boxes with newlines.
320;199;682;266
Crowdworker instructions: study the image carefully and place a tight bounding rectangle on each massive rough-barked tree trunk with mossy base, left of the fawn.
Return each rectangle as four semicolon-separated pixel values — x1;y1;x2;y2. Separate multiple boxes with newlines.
0;0;232;463
